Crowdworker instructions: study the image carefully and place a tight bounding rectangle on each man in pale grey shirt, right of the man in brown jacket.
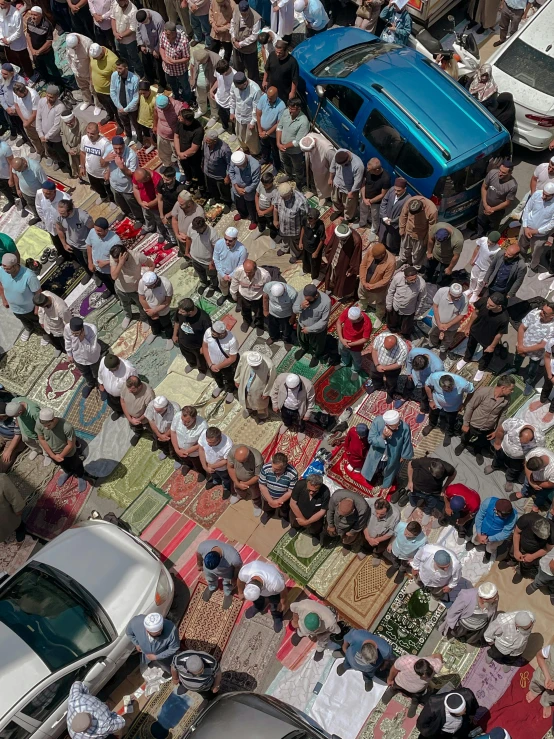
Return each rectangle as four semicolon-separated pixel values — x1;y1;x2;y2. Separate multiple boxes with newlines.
385;266;427;339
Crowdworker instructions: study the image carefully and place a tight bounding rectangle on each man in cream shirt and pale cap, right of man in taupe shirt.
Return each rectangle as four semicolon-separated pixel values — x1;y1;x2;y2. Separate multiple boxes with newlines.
485;612;535;672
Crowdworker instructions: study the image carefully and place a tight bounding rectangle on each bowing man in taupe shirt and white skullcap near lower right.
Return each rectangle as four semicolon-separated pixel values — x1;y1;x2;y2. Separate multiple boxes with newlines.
440;582;498;647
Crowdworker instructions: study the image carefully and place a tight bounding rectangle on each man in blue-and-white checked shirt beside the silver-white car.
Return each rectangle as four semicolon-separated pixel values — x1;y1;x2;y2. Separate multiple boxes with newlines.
67;680;125;739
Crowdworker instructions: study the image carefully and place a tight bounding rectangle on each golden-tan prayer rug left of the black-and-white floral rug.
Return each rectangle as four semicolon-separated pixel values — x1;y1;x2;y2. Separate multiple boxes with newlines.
327;557;398;629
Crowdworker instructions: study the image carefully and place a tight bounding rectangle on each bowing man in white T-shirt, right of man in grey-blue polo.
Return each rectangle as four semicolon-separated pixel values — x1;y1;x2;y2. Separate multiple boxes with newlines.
237;559;287;633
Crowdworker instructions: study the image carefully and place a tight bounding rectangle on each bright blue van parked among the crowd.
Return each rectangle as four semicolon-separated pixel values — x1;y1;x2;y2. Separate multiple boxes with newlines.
293;28;511;225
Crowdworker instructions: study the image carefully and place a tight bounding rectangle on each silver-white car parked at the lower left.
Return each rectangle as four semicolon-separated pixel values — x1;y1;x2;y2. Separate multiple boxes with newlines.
0;521;173;739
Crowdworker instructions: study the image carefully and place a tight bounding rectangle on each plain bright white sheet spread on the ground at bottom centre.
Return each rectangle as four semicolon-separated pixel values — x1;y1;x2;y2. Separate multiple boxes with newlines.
310;660;387;739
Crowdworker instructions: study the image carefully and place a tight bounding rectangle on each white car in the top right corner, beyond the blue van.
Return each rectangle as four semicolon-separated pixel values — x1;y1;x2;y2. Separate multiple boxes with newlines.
488;0;554;151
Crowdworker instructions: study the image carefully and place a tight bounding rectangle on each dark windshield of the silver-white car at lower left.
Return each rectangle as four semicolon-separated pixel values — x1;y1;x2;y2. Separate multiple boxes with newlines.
0;565;111;671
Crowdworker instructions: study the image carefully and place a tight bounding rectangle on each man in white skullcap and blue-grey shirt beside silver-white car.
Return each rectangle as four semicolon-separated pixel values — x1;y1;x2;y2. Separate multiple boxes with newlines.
125;613;181;674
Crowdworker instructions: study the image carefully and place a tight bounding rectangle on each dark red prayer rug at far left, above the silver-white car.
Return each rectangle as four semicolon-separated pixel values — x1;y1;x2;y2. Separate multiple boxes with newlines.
25;468;91;541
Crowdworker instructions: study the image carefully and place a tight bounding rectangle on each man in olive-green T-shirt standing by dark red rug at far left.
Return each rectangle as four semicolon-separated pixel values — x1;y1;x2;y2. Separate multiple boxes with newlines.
35;408;87;493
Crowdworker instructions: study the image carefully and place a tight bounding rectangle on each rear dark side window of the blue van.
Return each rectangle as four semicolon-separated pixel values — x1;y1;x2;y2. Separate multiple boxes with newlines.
363;109;433;178
